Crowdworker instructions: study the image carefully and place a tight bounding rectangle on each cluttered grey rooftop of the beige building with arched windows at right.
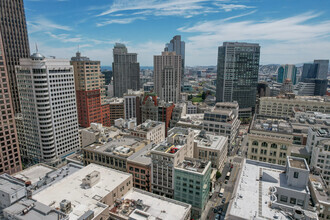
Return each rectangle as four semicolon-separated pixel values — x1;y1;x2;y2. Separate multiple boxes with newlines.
251;115;293;134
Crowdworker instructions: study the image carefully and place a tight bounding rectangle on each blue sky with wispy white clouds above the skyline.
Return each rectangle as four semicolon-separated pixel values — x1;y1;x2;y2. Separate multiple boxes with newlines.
24;0;330;66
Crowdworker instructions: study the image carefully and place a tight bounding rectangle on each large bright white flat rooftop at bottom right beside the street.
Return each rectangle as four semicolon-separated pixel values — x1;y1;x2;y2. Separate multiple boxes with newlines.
227;159;308;219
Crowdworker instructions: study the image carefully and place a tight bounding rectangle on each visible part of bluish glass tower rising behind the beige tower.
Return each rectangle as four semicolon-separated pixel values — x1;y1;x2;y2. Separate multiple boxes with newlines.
164;35;186;86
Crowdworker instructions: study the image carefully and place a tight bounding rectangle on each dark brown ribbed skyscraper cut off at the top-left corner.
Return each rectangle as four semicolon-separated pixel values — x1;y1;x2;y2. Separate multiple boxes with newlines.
0;0;30;113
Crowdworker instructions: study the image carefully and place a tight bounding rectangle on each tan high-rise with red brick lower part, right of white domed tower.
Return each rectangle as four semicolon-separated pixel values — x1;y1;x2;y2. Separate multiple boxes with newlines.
71;52;110;127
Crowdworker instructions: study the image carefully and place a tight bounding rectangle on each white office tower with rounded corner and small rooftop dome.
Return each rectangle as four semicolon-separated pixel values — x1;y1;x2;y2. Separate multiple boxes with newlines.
16;53;80;166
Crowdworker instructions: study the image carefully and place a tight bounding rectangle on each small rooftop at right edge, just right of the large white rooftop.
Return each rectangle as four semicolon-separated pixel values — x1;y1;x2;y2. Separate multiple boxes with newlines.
309;174;330;206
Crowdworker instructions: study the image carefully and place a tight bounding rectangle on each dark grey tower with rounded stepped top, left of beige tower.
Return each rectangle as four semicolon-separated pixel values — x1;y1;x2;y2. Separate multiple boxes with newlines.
112;43;140;97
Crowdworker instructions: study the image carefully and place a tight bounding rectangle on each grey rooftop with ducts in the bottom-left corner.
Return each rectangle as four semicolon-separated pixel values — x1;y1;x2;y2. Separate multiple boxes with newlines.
3;199;69;220
